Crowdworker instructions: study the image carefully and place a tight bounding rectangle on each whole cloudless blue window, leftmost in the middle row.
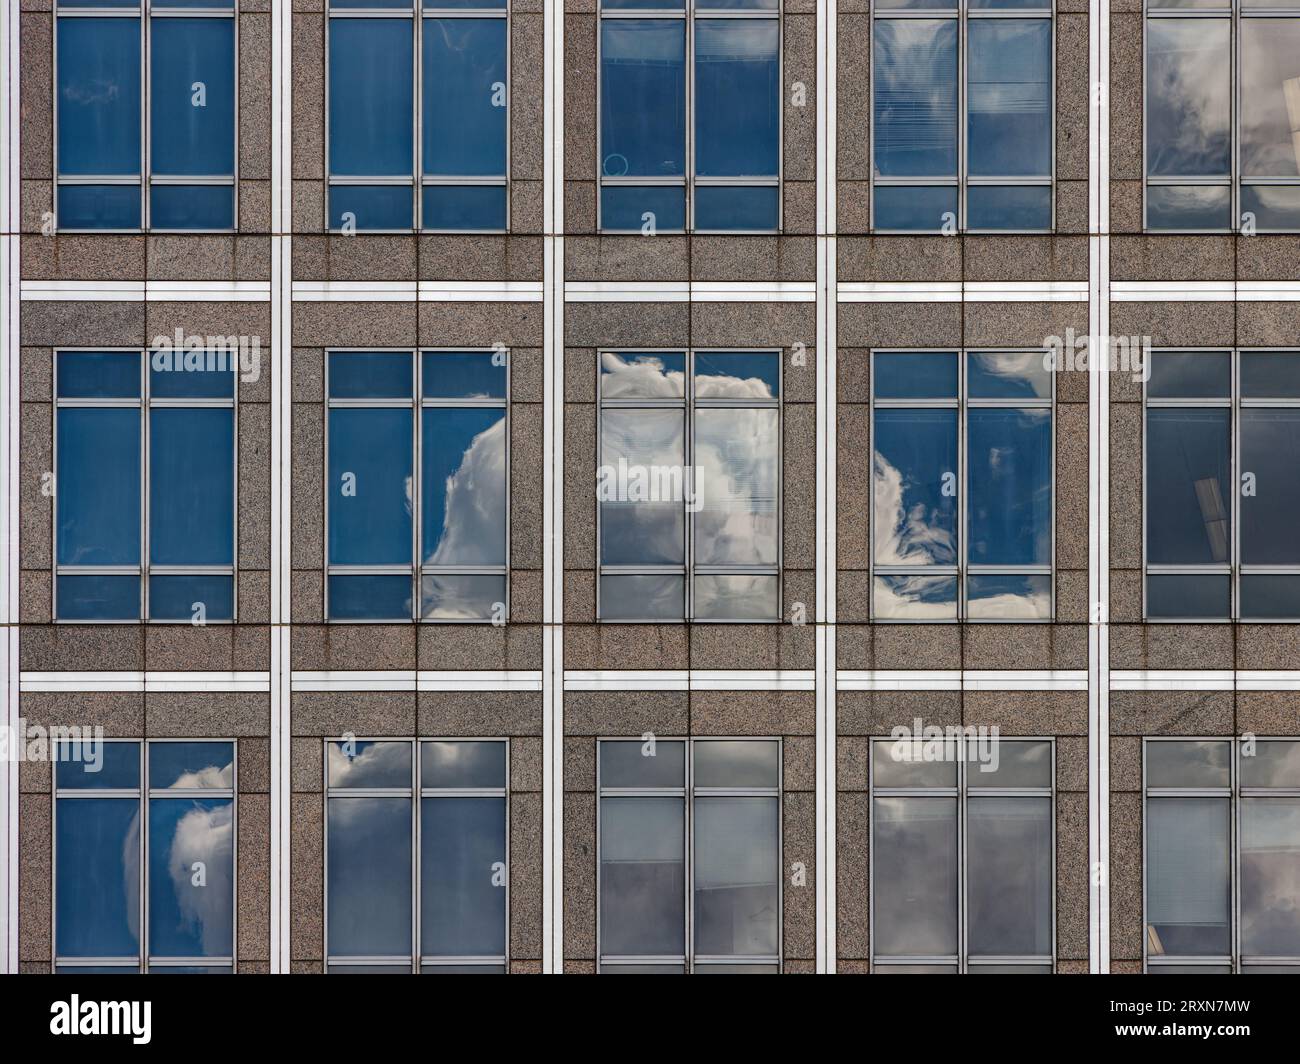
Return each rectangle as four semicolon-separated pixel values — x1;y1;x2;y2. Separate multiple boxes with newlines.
55;337;239;624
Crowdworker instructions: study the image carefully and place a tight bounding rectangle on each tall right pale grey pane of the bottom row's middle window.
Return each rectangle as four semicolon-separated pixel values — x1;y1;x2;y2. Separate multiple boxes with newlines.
694;796;781;957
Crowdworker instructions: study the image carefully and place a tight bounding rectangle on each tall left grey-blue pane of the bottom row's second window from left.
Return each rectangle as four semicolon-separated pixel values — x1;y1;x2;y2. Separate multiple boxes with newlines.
326;796;411;957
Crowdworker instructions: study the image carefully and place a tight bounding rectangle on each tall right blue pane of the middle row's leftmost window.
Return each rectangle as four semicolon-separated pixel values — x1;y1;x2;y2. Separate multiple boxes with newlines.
150;407;235;564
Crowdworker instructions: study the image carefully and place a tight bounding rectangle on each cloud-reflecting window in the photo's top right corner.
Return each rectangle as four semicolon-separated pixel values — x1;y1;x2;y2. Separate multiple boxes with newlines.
1145;0;1300;233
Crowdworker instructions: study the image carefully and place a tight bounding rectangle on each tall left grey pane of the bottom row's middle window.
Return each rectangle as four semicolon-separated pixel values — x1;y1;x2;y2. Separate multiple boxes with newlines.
601;796;686;957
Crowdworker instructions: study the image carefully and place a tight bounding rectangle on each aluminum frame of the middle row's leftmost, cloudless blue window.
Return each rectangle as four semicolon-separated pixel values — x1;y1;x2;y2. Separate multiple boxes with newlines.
49;346;241;626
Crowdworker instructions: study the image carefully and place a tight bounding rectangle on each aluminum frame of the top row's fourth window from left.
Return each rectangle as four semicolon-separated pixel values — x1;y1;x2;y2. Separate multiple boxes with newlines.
867;0;1058;237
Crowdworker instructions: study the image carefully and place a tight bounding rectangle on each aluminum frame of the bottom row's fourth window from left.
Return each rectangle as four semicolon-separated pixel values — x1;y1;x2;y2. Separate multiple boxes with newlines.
867;730;1061;974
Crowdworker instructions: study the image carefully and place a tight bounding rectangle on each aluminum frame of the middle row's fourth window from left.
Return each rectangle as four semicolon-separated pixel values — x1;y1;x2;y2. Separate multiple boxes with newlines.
867;346;1058;624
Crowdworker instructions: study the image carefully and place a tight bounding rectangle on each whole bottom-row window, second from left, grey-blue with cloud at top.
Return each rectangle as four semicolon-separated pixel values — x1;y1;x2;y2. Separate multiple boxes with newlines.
325;739;510;976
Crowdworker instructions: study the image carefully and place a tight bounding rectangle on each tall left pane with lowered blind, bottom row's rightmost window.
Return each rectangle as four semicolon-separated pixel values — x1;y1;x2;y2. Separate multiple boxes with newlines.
1147;796;1232;956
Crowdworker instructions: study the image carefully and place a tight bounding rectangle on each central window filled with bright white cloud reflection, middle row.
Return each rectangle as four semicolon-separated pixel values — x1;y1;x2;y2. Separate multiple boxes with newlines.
597;351;781;622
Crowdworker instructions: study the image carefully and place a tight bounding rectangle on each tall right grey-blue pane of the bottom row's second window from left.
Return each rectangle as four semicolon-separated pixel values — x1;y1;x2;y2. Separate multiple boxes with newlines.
420;797;506;957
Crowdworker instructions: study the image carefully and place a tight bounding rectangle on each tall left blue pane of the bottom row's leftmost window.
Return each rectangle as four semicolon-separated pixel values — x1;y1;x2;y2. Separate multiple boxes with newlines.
55;799;140;957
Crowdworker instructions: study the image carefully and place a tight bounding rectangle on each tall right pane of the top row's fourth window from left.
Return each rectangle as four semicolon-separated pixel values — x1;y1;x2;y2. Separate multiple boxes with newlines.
966;18;1052;177
